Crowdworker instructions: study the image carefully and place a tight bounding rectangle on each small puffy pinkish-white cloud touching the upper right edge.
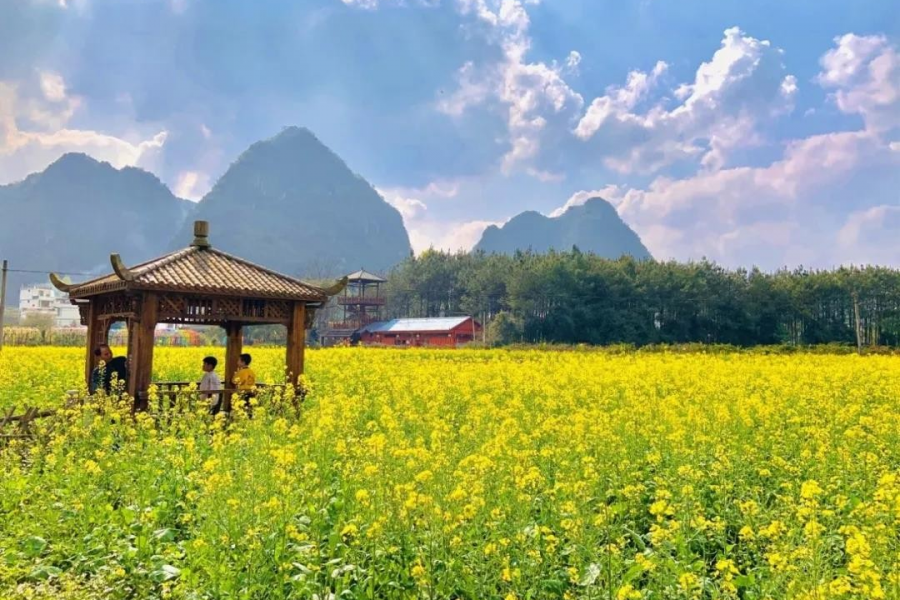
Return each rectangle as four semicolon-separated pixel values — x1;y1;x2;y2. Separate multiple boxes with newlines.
818;33;900;132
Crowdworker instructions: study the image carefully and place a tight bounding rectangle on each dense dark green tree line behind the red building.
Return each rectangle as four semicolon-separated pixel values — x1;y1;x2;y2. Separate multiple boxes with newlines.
386;248;900;346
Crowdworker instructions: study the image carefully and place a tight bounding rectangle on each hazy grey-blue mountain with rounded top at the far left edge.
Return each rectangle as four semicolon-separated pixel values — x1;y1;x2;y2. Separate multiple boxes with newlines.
0;153;192;305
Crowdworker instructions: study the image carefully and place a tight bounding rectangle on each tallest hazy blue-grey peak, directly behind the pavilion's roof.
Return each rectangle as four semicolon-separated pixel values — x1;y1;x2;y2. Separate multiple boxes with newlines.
172;127;412;277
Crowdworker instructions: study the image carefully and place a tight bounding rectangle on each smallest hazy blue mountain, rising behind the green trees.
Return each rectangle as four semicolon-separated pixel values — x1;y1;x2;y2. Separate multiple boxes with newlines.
474;197;652;259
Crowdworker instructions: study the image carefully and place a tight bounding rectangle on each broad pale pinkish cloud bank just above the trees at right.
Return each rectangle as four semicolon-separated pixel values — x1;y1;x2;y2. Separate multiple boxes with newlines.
604;131;900;268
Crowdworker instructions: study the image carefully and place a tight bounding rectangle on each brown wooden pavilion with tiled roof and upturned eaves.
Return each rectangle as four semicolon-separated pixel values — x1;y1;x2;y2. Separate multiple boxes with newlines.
50;221;346;410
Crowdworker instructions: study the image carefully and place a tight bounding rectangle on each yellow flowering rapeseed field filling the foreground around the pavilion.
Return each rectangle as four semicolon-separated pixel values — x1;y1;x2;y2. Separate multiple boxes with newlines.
0;348;900;600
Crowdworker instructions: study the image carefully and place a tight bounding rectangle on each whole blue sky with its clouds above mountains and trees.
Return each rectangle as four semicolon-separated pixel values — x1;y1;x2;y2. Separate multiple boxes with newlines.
0;0;900;269
